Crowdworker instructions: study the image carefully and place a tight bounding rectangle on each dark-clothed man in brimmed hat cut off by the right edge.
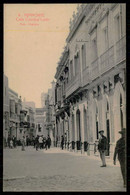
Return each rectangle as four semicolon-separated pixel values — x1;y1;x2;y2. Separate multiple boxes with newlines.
113;128;126;187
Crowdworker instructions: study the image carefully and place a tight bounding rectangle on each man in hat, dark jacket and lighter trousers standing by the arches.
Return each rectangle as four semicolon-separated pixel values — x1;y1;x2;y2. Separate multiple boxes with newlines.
98;130;107;167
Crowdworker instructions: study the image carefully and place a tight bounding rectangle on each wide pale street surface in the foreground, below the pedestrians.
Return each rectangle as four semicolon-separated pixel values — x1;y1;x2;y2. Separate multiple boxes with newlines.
3;147;125;191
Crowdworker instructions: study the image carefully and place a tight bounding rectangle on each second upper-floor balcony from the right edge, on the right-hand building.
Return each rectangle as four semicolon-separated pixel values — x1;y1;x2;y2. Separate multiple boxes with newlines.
100;46;114;74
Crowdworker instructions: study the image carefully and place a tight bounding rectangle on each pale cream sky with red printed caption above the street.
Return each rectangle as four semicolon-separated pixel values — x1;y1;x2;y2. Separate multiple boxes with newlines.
4;4;77;107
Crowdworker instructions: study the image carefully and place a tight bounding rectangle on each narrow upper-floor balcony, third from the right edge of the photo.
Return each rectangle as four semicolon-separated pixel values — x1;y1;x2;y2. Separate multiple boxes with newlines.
90;58;99;80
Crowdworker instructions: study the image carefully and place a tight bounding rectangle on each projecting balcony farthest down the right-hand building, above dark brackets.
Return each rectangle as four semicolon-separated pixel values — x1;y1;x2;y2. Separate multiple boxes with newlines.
66;73;81;97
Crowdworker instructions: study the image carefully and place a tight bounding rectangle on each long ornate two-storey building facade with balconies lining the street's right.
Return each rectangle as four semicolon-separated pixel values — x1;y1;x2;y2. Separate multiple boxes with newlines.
55;3;126;156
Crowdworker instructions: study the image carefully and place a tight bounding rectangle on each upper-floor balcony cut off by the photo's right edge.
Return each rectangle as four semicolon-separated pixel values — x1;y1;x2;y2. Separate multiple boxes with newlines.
116;36;126;63
